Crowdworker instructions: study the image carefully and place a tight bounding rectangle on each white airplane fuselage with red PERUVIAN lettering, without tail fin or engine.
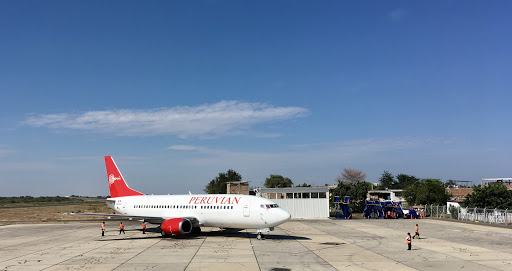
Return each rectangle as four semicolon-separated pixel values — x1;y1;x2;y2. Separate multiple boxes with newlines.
108;194;290;229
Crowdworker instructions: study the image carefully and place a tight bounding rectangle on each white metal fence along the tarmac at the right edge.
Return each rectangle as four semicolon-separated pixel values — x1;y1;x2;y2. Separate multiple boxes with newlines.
425;205;512;225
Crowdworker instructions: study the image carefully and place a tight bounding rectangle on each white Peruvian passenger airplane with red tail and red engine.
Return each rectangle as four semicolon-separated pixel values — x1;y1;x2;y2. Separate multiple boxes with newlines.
82;156;291;240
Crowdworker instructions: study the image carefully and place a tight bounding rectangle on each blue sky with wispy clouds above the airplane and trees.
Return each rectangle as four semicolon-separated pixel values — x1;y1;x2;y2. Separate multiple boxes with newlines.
0;1;512;196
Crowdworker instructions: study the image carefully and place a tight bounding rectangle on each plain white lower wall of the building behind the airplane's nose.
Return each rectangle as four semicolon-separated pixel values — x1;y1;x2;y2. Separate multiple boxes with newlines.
272;198;329;218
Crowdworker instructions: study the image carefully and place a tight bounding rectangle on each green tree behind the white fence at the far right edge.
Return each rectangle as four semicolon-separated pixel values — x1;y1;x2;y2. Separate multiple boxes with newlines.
464;183;512;209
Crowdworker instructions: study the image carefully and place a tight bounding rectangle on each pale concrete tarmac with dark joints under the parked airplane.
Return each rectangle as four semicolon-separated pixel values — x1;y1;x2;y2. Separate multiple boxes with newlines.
0;219;512;271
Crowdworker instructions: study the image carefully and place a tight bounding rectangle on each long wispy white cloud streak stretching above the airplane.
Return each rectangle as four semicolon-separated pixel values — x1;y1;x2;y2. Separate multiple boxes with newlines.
23;101;309;138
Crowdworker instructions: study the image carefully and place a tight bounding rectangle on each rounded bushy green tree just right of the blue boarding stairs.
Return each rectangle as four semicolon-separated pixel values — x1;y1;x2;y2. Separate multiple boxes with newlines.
404;179;450;205
